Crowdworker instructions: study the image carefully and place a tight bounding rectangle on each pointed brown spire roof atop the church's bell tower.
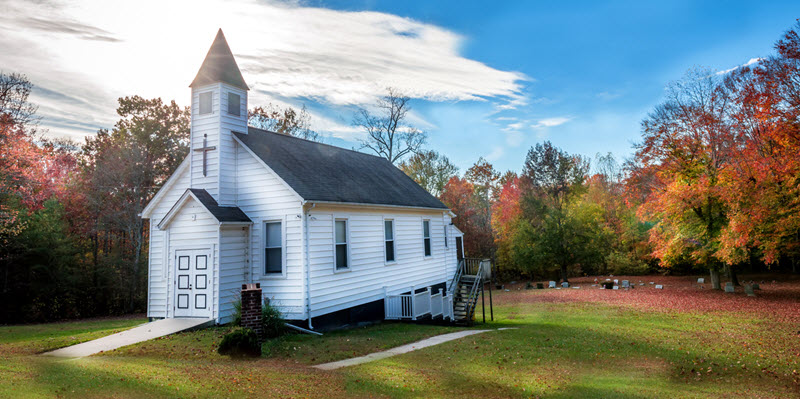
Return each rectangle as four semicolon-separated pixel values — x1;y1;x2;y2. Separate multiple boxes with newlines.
189;29;250;90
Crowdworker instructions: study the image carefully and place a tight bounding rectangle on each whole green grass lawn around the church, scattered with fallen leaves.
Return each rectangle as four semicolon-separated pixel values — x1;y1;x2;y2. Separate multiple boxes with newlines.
0;280;800;398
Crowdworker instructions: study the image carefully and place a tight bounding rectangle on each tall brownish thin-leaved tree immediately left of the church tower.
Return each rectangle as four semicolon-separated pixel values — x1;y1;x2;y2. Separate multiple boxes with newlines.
82;96;190;311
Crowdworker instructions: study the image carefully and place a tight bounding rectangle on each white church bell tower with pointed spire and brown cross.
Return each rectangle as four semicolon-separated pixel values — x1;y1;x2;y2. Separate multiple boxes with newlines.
189;29;249;206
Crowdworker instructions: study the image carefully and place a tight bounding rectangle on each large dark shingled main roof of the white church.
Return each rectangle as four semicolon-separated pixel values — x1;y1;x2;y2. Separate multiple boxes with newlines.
233;127;447;209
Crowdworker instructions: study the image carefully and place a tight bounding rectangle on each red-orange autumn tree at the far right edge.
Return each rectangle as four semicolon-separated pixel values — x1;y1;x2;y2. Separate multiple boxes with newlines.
719;23;800;272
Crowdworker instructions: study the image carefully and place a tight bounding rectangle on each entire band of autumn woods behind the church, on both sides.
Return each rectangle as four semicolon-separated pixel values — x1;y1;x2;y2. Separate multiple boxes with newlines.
0;20;800;323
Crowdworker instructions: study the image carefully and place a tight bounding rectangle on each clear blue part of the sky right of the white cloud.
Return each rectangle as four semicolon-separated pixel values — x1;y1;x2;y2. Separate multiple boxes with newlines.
316;1;800;170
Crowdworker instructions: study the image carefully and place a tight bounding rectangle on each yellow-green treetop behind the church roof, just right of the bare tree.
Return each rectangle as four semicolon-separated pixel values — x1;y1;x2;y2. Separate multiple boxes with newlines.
399;150;458;197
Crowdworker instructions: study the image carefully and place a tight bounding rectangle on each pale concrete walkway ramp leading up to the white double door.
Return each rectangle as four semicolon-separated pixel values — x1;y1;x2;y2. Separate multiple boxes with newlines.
42;318;214;358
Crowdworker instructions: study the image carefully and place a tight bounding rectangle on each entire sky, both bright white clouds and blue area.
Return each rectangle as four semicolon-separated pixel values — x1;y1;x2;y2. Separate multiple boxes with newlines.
0;0;800;171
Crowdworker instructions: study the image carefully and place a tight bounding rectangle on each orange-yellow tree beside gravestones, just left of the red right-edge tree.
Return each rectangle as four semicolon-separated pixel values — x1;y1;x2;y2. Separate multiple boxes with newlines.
634;69;736;289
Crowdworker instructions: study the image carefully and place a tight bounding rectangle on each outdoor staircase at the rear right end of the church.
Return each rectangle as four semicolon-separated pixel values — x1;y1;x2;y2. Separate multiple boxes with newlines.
450;258;483;324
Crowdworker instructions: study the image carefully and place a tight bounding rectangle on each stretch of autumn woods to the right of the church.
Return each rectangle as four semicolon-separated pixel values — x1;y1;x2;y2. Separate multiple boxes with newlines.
401;23;800;289
